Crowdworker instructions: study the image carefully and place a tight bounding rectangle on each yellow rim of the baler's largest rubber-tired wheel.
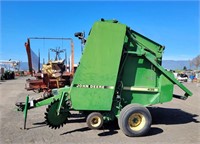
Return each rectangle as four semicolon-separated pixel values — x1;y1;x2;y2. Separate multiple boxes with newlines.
128;113;146;131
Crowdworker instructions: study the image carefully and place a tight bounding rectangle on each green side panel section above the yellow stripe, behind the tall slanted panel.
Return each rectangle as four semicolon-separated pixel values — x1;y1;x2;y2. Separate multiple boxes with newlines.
122;55;157;87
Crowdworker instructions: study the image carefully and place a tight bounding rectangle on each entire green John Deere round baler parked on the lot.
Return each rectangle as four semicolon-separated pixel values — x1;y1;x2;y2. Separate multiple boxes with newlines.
17;19;192;137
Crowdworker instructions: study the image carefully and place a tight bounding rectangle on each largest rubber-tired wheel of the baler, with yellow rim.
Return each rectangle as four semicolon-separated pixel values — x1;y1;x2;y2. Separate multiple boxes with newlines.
118;104;152;137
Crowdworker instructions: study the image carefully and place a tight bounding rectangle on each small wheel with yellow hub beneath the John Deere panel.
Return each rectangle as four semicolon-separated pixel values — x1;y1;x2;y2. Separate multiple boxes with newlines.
86;112;103;129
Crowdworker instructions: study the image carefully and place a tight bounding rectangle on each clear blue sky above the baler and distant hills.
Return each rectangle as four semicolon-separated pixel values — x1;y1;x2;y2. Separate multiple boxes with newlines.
0;1;200;63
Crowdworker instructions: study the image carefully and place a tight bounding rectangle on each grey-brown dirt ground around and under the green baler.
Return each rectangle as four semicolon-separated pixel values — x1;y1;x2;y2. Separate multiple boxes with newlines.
0;77;200;144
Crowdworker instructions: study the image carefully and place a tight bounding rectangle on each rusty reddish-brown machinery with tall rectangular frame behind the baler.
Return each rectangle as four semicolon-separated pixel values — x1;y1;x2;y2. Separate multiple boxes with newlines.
25;38;74;92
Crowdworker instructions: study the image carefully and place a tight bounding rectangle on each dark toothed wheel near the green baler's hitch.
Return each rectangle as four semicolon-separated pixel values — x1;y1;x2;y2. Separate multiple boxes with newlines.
45;100;69;129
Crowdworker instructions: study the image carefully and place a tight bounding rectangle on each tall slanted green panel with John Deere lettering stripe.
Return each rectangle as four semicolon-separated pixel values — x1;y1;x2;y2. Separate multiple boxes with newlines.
70;22;126;110
